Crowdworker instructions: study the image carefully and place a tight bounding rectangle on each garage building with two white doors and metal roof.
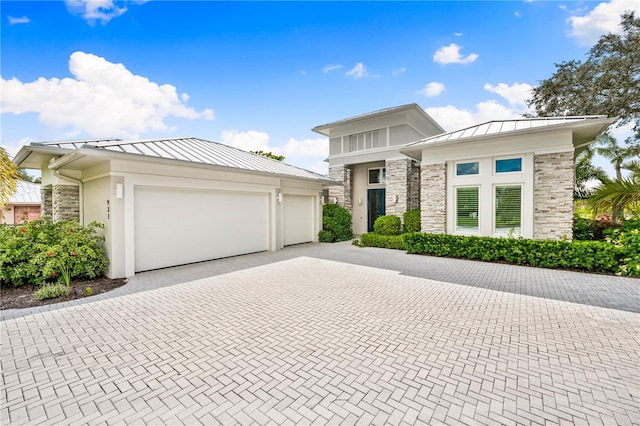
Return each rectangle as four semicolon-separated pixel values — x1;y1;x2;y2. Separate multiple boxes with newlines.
14;138;336;278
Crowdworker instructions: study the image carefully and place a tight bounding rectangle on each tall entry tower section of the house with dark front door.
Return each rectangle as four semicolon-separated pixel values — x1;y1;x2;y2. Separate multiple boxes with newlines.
313;104;444;234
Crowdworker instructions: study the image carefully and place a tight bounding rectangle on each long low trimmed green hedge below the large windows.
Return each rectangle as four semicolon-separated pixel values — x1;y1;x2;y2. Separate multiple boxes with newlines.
404;231;624;275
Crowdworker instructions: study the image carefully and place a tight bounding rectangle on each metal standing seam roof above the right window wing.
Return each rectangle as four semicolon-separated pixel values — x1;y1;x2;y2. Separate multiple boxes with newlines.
405;115;607;148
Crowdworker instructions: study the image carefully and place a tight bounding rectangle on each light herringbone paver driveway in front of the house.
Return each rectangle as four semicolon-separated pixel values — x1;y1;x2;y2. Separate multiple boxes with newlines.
0;244;640;425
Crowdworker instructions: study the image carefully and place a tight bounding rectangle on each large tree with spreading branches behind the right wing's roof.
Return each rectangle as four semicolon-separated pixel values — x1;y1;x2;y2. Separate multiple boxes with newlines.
528;12;640;150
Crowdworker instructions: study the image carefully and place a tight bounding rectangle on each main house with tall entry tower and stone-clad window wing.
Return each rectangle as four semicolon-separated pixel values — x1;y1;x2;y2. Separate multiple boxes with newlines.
313;104;614;239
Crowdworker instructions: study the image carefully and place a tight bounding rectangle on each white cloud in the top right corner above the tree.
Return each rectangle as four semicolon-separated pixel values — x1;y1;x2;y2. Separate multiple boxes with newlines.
567;0;640;45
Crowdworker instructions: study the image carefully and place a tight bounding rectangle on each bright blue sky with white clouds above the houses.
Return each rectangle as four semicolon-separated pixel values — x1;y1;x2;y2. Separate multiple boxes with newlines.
1;0;640;173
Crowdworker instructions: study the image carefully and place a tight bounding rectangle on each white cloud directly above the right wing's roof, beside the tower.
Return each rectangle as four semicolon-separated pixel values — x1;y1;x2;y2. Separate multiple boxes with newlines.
425;101;522;131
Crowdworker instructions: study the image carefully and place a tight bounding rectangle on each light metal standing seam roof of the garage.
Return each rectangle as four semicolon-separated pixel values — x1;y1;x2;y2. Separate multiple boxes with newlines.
32;137;331;181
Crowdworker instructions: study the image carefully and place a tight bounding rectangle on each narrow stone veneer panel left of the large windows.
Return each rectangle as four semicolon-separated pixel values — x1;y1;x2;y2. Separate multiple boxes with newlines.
420;163;447;234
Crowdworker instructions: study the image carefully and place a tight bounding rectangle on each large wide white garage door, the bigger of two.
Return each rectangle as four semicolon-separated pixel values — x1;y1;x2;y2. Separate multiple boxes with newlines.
134;186;269;272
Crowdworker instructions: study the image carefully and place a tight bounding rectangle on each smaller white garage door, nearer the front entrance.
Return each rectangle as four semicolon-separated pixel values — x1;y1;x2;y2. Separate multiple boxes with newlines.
283;194;314;246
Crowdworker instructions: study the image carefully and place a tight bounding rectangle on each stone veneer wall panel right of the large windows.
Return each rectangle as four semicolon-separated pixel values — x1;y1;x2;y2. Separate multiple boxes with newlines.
533;152;575;240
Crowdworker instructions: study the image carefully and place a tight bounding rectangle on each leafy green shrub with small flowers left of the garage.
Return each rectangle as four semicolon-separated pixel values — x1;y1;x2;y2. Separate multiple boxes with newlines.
0;219;108;287
